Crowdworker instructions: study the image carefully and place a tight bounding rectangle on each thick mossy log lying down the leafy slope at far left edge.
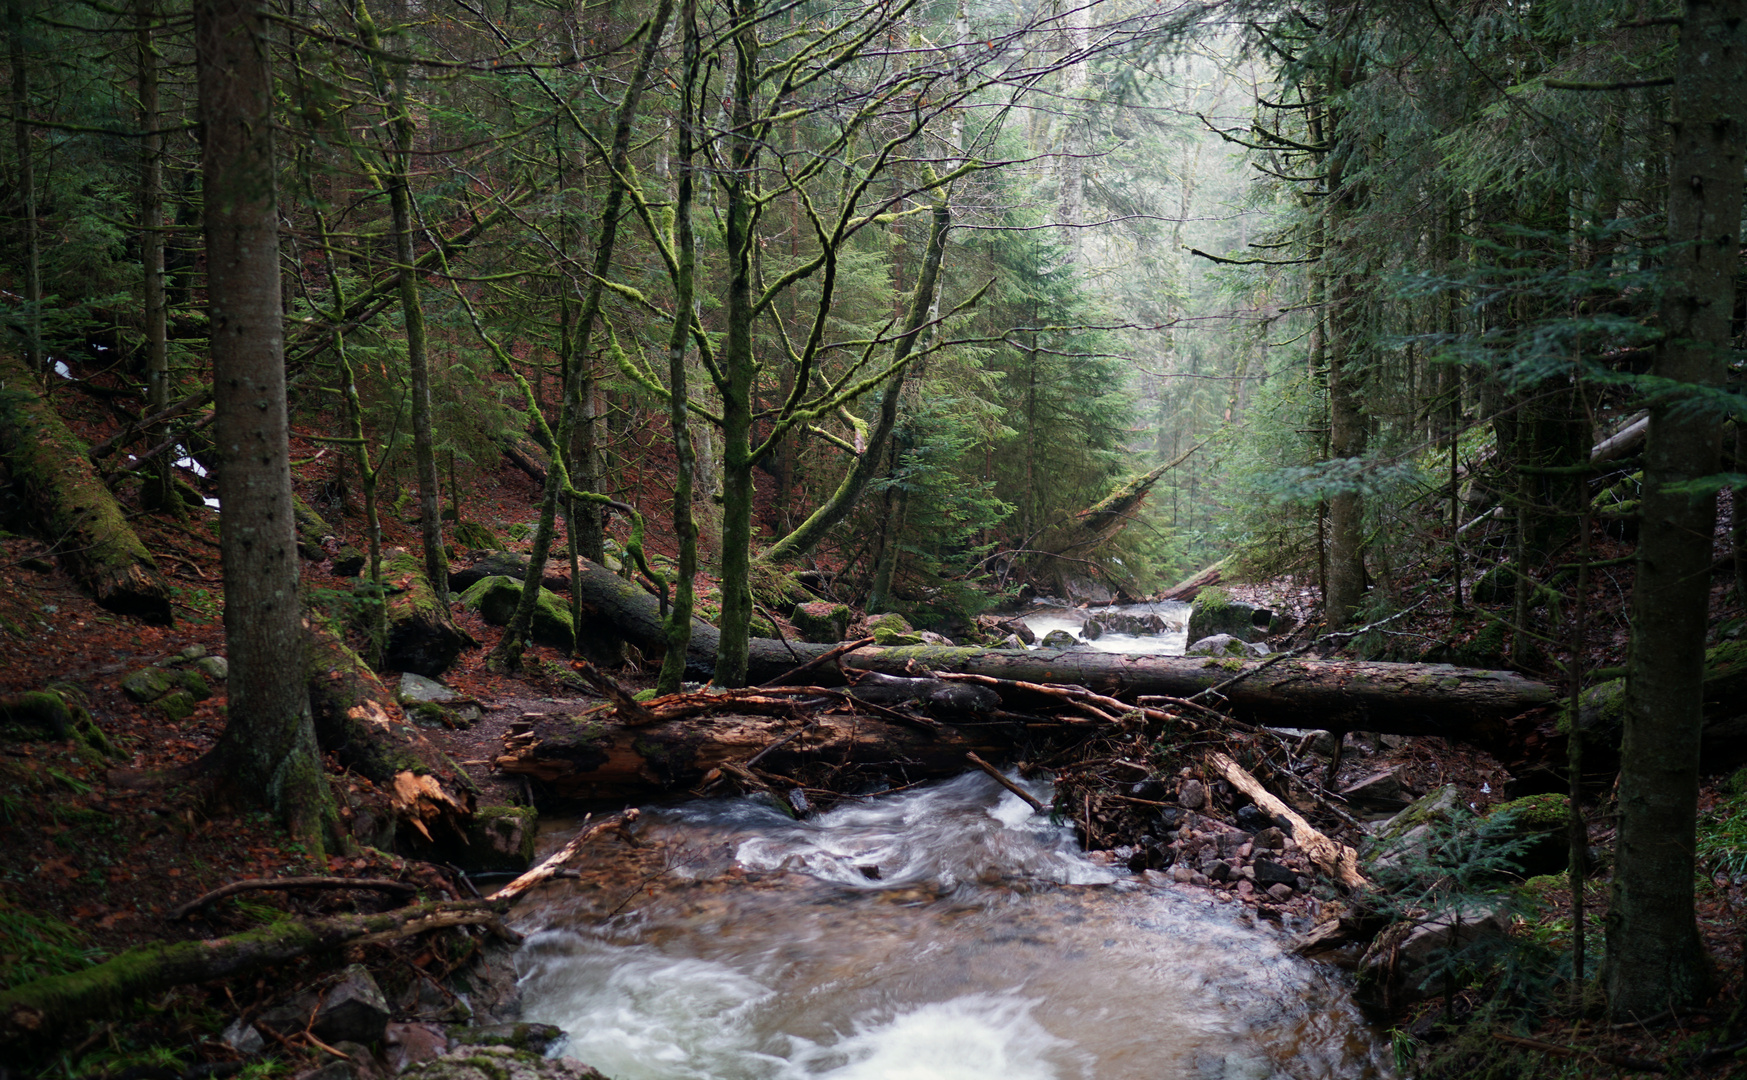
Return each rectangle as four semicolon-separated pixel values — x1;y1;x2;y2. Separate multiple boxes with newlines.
0;353;171;626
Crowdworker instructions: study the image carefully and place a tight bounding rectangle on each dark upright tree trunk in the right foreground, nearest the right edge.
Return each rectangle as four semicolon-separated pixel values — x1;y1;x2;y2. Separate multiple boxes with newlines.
1604;0;1747;1022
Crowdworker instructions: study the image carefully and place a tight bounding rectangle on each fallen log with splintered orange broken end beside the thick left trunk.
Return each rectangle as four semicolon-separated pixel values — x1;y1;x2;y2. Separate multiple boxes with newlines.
304;626;473;842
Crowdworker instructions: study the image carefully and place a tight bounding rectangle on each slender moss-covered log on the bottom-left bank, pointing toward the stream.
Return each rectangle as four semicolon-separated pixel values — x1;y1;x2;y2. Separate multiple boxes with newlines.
0;900;508;1045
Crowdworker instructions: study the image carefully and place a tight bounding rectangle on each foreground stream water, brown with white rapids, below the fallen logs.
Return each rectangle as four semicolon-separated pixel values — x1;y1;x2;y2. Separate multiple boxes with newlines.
521;774;1387;1080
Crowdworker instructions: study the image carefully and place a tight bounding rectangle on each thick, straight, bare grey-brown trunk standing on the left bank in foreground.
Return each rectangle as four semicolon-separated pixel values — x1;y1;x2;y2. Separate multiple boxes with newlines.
194;0;335;858
